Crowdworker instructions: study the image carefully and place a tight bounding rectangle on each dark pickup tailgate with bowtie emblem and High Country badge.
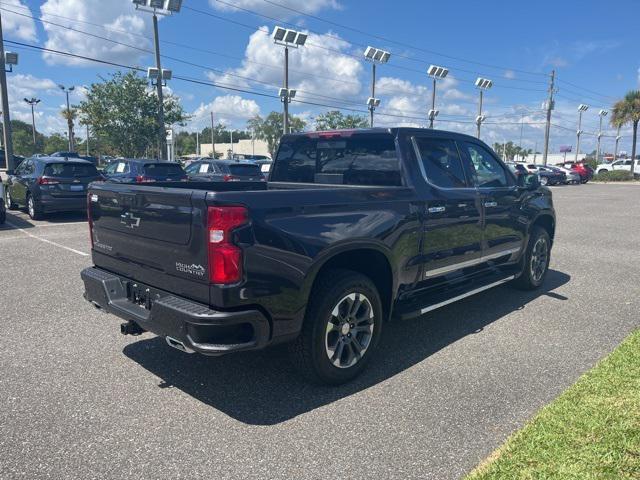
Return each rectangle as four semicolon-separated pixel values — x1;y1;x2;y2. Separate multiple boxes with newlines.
89;183;209;302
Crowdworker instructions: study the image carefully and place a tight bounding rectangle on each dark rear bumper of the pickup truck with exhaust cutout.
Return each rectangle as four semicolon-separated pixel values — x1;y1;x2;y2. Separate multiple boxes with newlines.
81;267;271;355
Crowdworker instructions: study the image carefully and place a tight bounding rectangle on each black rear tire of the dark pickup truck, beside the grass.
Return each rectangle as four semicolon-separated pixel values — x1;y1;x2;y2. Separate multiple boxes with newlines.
289;270;383;385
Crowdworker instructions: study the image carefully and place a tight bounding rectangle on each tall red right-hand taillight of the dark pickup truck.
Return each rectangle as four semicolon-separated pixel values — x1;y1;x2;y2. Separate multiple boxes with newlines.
207;206;249;285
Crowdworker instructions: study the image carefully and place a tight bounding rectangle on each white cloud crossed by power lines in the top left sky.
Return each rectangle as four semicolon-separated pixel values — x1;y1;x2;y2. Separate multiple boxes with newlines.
40;0;151;66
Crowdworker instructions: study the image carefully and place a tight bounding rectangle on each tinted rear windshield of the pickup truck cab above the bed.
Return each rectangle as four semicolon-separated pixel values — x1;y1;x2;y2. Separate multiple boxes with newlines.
271;134;402;186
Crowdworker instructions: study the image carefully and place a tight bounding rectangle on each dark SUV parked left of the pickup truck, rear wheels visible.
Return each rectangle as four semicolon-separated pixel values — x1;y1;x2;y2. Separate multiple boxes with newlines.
5;157;102;220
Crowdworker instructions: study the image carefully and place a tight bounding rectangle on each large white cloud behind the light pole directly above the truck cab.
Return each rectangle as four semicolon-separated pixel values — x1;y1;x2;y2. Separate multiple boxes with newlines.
208;27;363;103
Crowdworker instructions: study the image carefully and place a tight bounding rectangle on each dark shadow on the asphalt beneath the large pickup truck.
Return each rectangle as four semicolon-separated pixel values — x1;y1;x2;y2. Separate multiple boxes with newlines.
123;270;571;425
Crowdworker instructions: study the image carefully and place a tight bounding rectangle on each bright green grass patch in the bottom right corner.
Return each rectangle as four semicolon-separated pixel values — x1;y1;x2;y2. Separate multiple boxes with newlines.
466;330;640;480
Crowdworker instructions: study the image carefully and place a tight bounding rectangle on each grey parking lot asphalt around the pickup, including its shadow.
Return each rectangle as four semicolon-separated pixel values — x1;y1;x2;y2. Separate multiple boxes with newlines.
0;184;640;480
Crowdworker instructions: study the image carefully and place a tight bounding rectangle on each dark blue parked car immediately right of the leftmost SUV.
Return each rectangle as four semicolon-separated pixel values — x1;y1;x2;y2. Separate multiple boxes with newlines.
104;158;189;183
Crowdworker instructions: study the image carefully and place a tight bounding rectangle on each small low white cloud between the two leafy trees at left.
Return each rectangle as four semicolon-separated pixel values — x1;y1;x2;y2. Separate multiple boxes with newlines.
190;95;260;129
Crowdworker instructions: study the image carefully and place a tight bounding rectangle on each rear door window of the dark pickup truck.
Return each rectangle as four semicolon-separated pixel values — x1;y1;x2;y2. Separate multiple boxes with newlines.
415;138;469;188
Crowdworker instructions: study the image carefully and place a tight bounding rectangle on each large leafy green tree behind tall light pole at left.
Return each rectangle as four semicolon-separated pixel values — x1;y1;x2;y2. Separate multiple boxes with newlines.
77;72;188;157
